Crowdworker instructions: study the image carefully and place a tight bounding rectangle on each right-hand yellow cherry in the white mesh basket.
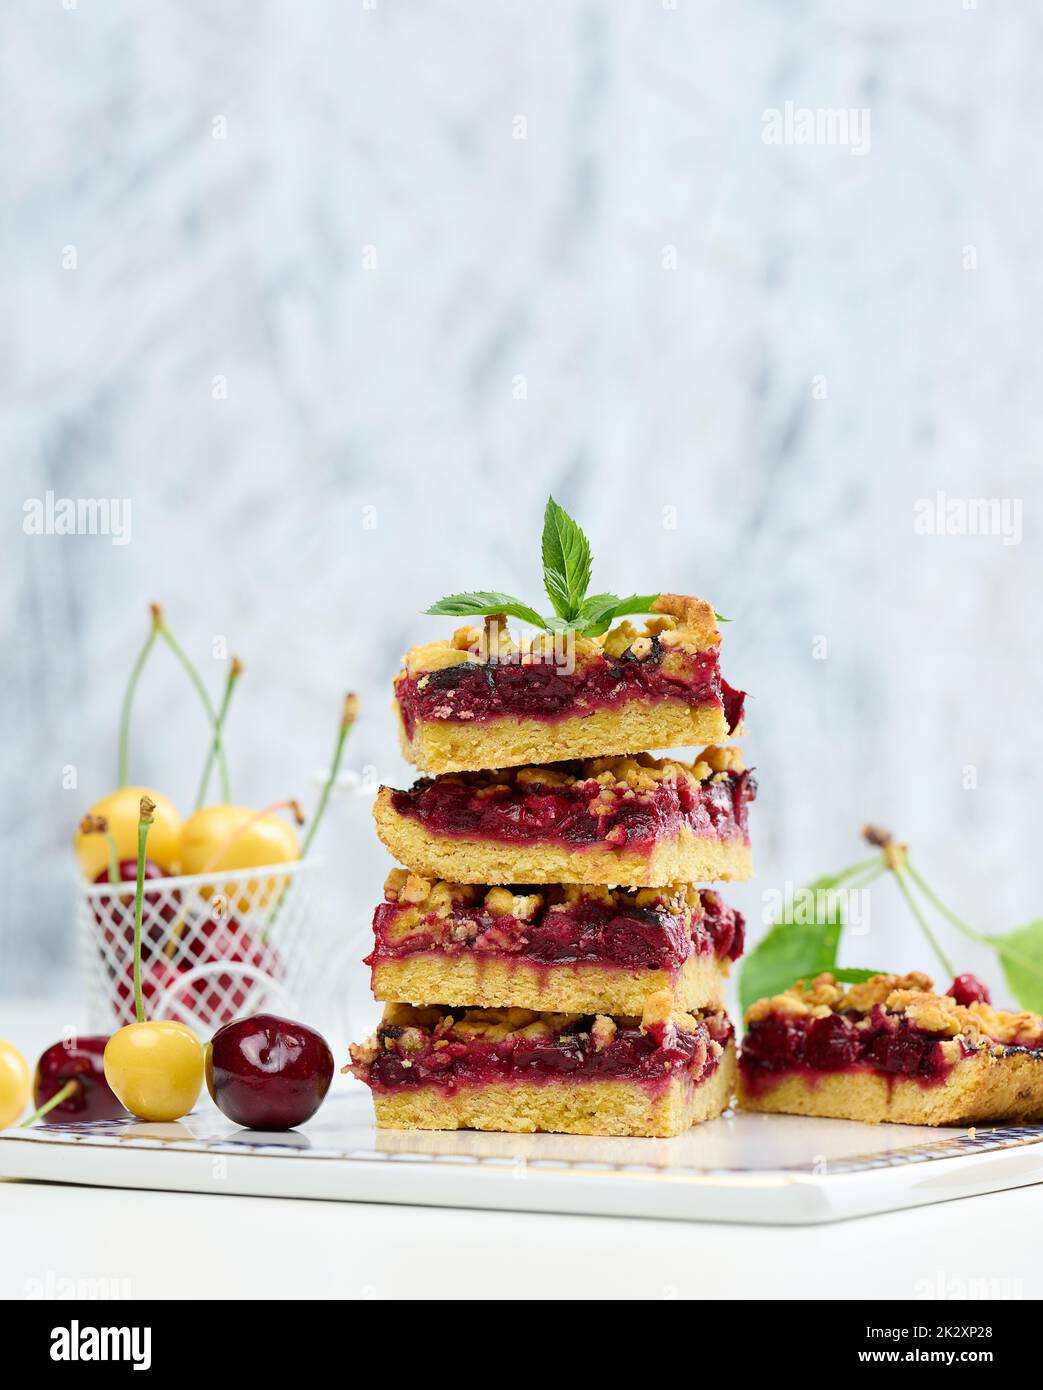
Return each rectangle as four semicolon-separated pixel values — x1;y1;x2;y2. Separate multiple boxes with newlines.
181;802;303;912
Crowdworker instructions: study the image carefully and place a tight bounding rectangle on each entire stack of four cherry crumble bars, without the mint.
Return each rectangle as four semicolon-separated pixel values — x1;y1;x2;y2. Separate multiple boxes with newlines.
350;595;755;1136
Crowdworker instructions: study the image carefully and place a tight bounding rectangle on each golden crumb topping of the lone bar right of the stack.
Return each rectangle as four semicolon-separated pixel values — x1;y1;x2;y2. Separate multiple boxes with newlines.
747;970;1043;1047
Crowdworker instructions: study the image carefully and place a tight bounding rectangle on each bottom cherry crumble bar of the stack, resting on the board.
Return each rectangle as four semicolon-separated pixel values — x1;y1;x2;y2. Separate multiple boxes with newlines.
345;994;736;1137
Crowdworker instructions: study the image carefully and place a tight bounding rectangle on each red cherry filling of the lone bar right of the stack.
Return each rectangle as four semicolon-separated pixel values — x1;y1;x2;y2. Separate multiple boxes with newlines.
738;1004;990;1094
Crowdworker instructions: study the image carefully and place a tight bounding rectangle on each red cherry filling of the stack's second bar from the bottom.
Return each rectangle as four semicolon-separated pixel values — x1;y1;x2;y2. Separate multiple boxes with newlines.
366;890;745;970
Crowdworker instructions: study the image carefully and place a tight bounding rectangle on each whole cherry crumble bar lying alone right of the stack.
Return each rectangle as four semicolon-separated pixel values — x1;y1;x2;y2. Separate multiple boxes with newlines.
738;973;1043;1125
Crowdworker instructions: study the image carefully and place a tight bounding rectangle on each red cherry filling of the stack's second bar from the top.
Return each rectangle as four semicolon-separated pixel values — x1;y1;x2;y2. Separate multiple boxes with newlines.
391;763;757;852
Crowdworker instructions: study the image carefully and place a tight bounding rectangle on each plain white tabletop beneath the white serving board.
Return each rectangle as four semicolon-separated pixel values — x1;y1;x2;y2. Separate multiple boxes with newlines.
0;1001;1043;1298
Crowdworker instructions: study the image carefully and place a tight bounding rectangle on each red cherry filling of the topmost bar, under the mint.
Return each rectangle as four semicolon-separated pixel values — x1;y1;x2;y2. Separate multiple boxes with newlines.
395;637;745;738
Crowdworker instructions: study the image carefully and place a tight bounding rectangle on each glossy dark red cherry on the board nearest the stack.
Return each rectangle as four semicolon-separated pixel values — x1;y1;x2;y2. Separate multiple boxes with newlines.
206;1013;334;1130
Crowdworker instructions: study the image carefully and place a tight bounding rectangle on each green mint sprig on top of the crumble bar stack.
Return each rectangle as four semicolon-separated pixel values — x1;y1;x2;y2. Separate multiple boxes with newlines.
426;498;670;637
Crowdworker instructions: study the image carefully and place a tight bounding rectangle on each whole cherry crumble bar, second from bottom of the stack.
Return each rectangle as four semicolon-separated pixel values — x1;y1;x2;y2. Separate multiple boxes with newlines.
366;869;744;1015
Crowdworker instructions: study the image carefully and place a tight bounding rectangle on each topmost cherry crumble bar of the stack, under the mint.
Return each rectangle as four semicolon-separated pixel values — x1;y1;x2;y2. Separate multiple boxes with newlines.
394;594;744;774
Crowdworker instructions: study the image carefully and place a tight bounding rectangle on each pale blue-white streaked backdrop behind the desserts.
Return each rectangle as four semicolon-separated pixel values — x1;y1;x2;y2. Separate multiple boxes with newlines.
0;0;1043;1023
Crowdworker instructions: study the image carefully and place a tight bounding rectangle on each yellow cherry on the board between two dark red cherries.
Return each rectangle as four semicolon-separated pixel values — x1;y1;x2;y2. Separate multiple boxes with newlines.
104;1019;203;1123
